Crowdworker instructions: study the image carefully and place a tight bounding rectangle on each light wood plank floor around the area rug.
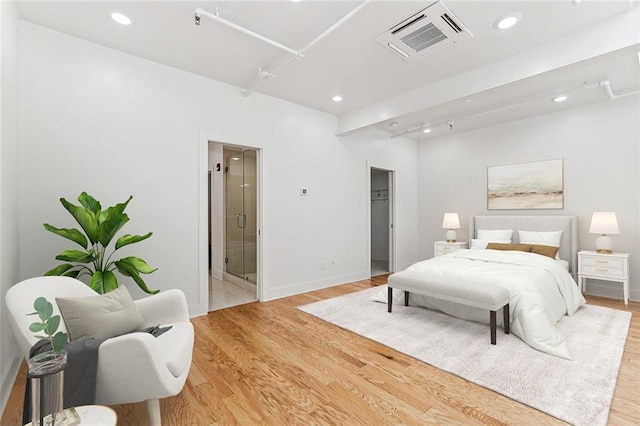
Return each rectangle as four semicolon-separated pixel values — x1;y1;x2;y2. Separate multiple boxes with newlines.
0;277;640;426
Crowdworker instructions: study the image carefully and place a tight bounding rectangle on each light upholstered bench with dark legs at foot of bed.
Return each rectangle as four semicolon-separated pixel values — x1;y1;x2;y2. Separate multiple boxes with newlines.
387;271;510;345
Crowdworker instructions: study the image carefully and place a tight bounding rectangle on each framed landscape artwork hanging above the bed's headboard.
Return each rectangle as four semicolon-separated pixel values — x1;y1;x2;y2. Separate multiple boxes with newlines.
487;159;564;210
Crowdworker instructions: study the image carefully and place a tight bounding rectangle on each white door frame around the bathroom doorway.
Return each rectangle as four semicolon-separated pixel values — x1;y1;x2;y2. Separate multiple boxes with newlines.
196;131;264;315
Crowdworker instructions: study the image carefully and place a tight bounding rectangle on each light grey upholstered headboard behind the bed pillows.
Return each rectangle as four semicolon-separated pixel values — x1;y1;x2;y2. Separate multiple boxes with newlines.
469;215;578;278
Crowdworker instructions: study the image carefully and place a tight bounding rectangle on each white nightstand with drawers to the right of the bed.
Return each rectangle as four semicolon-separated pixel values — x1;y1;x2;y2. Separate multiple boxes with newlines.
578;250;629;305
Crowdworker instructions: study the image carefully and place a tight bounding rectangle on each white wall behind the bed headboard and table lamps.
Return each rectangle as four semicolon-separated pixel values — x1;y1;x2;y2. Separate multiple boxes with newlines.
418;96;640;300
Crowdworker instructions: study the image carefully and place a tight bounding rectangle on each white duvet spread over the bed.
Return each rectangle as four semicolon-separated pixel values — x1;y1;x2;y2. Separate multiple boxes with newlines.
372;249;586;359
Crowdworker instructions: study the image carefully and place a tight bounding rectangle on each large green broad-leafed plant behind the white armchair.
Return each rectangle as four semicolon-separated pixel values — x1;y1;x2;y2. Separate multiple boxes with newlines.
44;192;159;294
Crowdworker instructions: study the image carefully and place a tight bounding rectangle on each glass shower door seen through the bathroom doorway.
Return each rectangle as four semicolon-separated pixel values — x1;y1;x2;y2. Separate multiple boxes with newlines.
225;150;257;283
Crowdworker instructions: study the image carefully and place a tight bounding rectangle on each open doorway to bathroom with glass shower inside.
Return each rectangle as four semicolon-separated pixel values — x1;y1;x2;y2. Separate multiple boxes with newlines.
209;142;259;311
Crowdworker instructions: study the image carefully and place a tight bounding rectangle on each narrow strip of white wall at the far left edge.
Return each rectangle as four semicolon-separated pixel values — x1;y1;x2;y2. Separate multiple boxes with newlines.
0;2;19;411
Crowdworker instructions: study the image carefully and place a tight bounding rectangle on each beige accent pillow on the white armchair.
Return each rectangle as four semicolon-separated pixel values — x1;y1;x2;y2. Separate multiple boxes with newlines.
56;285;144;340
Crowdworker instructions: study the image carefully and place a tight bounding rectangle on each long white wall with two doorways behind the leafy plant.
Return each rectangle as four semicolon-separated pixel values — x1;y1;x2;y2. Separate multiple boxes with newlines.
20;22;416;314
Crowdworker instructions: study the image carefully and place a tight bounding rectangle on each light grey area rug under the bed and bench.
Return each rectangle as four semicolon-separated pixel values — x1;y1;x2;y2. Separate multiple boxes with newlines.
299;286;631;425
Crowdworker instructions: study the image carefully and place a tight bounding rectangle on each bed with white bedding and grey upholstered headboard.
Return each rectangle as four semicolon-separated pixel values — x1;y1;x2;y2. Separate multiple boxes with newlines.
372;215;586;359
